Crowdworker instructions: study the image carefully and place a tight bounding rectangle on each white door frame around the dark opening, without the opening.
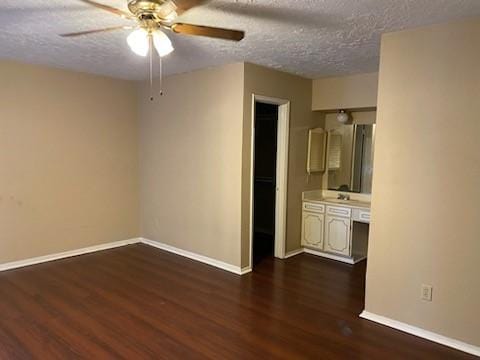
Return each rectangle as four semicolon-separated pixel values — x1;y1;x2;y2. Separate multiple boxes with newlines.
249;94;290;268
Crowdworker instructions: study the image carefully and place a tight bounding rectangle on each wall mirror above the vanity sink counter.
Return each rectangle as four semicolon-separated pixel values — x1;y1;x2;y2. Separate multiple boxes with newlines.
327;124;375;194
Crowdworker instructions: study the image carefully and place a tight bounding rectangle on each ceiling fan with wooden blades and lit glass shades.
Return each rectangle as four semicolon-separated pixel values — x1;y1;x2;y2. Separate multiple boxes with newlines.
60;0;245;100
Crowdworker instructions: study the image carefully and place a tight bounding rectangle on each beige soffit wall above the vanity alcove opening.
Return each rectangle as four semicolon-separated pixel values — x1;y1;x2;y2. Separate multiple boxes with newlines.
312;73;378;110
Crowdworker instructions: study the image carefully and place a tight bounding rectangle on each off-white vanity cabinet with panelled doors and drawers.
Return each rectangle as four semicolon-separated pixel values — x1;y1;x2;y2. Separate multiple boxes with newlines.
301;199;370;264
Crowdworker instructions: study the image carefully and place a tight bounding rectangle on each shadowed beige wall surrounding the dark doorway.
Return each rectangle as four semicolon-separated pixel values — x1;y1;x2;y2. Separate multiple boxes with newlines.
242;63;324;266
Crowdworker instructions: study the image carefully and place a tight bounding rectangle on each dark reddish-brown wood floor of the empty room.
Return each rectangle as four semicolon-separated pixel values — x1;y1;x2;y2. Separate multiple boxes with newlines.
0;245;473;359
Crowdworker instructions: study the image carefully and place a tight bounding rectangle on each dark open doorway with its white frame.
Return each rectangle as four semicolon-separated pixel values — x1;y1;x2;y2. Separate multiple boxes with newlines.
250;95;290;267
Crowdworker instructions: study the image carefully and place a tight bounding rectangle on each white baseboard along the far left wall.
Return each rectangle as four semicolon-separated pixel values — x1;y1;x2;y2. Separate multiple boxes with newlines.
0;238;140;271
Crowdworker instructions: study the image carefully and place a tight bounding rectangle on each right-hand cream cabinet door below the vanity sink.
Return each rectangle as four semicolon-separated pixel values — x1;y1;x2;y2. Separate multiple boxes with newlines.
324;216;351;256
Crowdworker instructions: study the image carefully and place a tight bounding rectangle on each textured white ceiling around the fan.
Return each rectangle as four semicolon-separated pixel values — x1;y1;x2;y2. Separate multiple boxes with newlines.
0;0;480;79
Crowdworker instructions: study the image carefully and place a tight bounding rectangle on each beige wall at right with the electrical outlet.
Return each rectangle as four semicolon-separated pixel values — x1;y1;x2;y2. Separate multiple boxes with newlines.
366;19;480;346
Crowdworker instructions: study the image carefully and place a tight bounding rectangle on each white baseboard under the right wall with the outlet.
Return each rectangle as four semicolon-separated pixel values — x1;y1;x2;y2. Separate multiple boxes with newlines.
360;311;480;356
